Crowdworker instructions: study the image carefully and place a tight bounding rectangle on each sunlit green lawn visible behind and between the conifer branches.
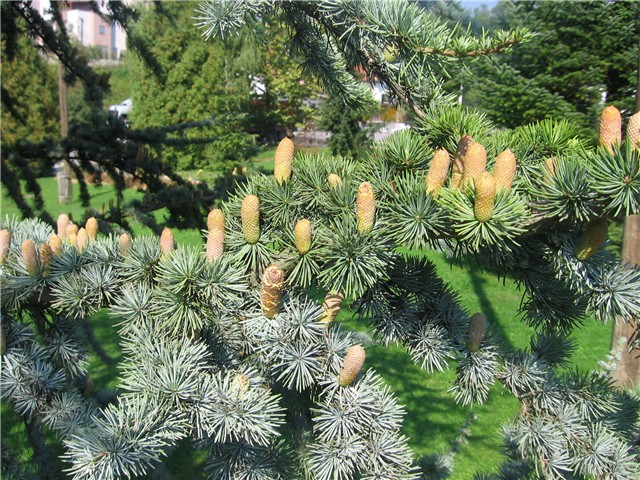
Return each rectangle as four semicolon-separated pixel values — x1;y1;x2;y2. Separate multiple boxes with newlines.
1;175;612;480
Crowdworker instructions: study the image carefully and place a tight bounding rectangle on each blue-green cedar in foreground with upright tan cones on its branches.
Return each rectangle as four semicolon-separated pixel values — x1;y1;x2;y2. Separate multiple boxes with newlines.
0;0;640;480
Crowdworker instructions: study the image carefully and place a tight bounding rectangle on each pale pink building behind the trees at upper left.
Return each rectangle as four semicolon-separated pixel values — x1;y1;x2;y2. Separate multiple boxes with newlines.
33;0;127;60
